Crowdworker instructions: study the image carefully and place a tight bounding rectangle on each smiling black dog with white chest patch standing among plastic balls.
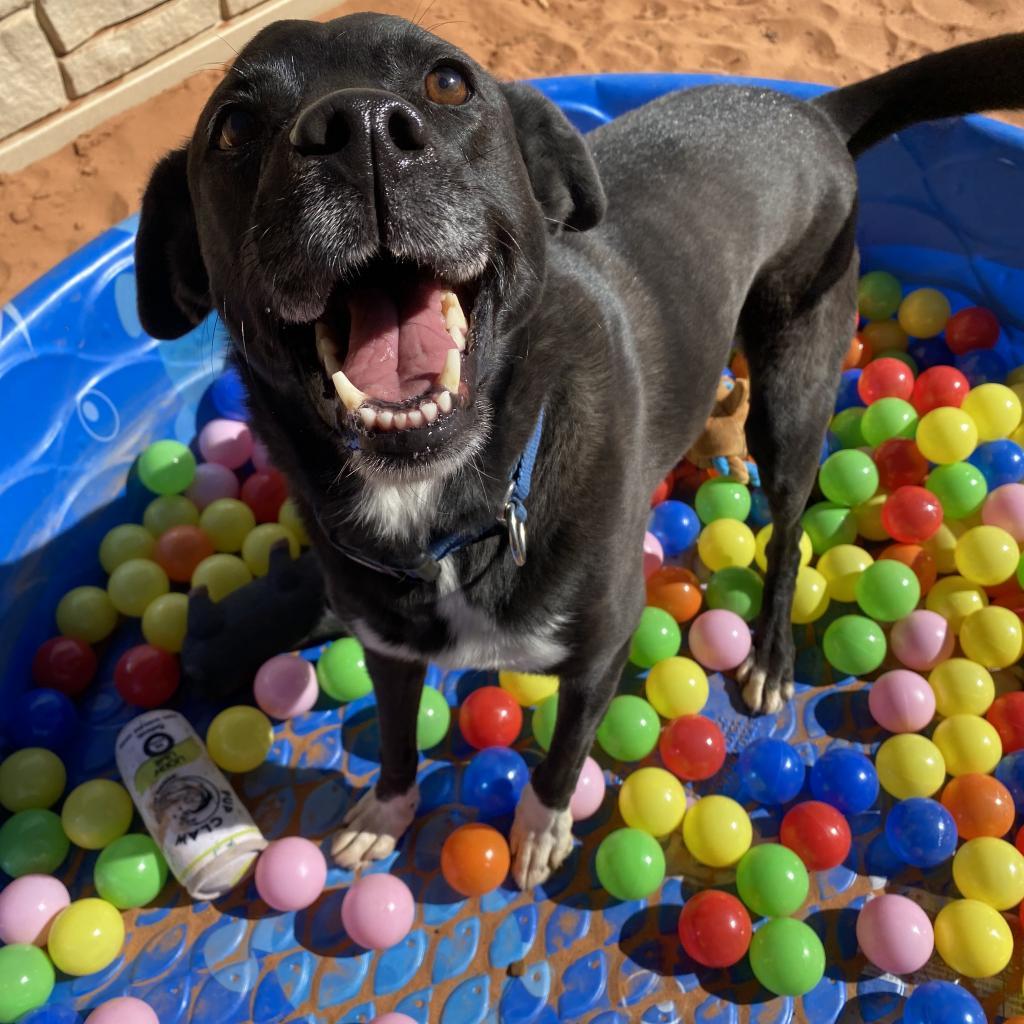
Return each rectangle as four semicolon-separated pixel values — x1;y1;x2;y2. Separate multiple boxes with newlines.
137;14;1024;886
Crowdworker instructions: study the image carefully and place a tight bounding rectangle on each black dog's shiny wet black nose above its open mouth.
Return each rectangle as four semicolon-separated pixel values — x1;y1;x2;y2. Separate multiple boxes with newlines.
289;89;430;161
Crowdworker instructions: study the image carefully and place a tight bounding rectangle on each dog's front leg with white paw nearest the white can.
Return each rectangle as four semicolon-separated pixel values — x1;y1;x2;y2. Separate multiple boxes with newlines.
331;648;426;868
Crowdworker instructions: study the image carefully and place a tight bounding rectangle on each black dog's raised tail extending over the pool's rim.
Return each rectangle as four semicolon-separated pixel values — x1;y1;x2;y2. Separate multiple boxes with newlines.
813;33;1024;157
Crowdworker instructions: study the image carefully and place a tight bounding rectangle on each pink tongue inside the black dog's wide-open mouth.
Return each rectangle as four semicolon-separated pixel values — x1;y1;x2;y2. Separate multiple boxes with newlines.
342;282;456;402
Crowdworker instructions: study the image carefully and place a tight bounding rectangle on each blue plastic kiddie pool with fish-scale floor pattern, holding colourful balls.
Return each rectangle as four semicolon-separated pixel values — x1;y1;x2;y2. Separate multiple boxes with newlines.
0;75;1024;1024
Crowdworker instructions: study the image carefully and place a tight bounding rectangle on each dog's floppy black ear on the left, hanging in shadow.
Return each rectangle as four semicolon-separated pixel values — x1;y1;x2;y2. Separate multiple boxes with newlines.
135;150;210;340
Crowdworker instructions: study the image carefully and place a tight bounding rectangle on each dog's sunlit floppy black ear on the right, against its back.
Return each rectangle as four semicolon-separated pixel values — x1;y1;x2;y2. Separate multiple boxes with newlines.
502;82;607;231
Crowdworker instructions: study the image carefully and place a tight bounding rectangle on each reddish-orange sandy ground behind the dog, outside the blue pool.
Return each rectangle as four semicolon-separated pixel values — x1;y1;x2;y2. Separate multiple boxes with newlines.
0;0;1024;305
